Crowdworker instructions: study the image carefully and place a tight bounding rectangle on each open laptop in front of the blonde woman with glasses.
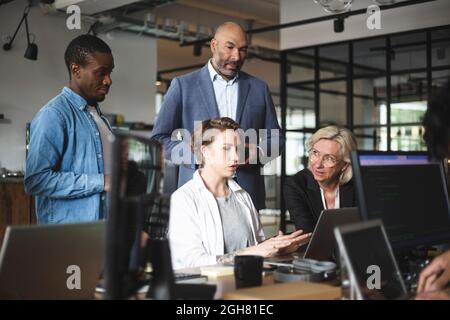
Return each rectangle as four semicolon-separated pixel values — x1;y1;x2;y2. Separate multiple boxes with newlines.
303;207;361;261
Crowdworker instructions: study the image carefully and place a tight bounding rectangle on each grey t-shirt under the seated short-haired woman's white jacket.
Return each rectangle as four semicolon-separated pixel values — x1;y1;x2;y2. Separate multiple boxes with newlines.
216;191;253;253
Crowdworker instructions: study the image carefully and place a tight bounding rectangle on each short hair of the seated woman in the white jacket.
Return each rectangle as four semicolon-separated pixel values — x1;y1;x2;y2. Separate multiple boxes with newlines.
191;117;239;168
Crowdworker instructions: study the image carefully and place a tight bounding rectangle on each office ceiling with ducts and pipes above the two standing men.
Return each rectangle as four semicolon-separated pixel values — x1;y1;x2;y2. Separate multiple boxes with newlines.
51;0;279;49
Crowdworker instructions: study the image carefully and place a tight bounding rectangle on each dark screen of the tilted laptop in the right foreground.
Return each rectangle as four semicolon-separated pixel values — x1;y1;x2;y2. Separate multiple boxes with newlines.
340;224;406;300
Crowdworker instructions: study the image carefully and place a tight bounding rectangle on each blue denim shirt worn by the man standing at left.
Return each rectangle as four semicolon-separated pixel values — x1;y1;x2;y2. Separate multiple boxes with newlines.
25;87;110;223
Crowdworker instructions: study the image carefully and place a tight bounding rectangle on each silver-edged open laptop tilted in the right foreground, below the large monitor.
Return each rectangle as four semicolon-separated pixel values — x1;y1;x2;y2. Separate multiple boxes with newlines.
334;219;410;300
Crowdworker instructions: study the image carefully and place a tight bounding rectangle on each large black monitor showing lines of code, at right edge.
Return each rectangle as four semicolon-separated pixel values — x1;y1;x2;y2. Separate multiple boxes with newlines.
352;151;450;249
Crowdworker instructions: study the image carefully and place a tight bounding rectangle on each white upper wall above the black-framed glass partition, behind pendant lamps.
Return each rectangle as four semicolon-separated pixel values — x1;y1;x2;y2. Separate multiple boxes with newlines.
280;0;450;50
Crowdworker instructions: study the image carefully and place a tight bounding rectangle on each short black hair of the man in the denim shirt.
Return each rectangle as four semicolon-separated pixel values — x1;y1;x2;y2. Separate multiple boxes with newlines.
64;34;111;76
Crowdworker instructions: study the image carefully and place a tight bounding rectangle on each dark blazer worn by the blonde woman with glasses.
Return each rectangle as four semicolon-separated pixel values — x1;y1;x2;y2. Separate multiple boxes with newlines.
284;169;356;232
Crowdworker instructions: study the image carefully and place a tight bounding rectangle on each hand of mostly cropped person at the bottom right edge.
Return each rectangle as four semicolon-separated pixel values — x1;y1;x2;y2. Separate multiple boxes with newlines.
417;251;450;293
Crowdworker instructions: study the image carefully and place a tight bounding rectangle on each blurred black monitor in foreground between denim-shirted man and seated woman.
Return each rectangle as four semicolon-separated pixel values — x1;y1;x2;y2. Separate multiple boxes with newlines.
105;131;170;299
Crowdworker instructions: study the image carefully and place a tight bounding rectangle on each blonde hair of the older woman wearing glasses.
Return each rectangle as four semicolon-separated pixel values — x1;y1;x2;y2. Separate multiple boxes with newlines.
308;126;357;185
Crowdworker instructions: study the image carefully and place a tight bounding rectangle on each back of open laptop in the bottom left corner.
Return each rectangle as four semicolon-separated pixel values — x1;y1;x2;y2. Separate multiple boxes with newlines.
0;221;105;299
